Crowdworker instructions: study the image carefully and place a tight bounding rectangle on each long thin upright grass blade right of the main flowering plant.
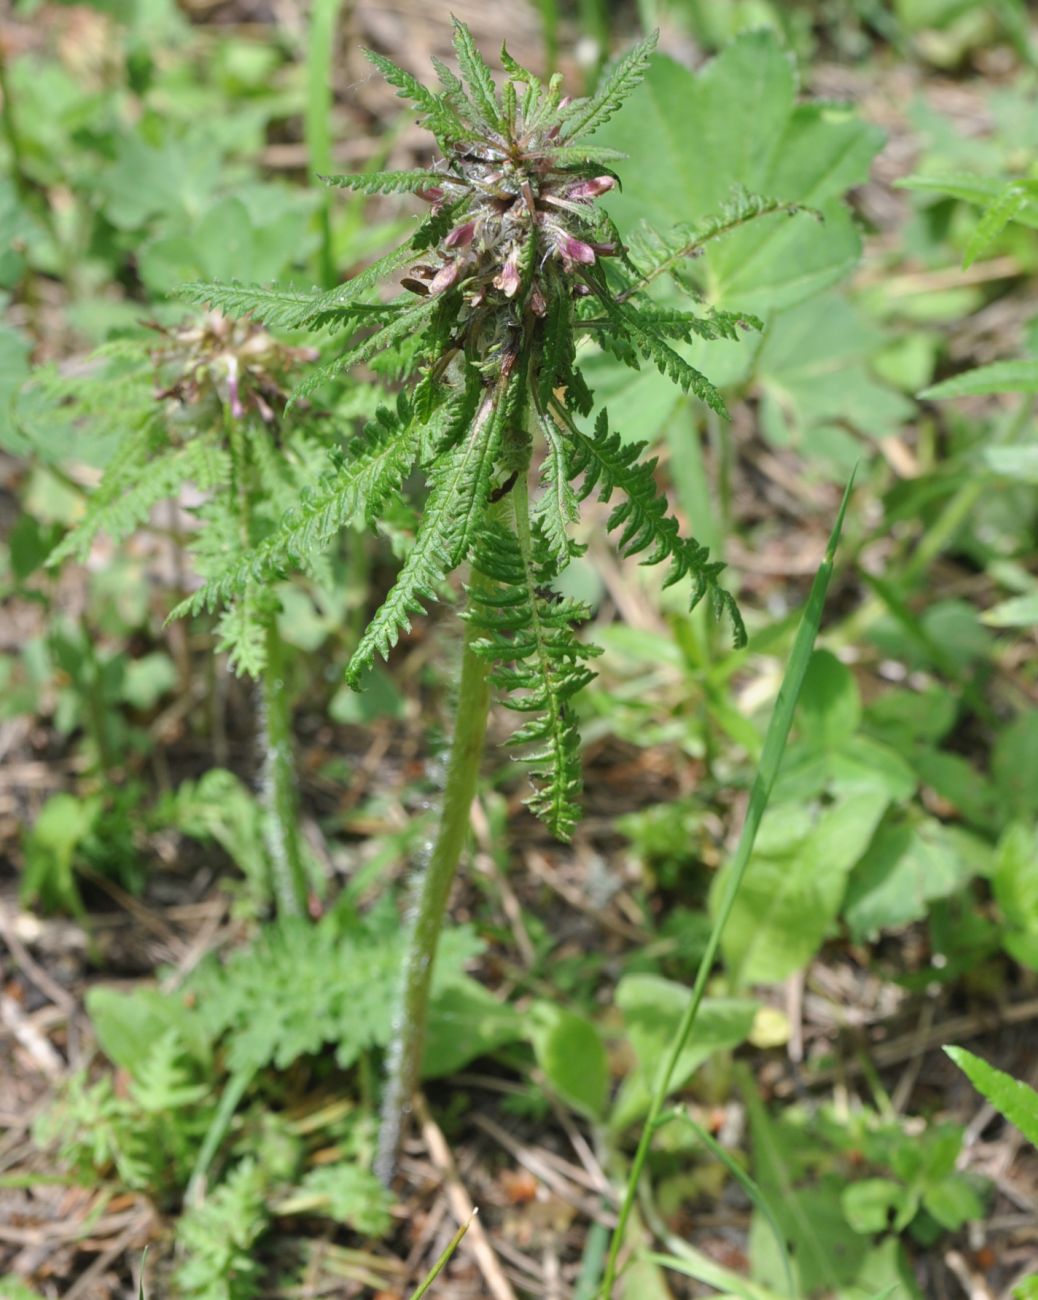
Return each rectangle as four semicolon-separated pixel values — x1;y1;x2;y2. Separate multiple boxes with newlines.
600;475;853;1297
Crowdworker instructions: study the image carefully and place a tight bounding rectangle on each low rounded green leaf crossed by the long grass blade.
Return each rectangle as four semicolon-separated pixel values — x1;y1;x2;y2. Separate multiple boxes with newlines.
610;975;757;1128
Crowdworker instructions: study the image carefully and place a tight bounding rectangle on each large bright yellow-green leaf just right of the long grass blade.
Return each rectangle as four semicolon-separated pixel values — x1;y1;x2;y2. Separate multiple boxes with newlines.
712;790;890;984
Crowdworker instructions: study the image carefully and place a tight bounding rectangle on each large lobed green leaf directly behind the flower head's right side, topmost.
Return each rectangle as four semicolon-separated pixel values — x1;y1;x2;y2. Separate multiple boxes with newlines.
602;31;882;312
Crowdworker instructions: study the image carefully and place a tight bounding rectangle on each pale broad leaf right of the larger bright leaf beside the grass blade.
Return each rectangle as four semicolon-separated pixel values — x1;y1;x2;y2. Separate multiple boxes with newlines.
843;818;990;940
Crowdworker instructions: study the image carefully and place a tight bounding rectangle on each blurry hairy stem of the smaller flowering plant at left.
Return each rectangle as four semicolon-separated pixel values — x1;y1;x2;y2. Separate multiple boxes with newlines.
260;615;307;917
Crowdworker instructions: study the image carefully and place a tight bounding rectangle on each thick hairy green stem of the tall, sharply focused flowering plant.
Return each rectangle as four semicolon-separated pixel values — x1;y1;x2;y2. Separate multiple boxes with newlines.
376;603;490;1183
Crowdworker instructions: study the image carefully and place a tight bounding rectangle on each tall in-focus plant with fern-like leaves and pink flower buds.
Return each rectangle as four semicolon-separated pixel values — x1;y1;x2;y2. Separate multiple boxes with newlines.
180;23;764;1175
